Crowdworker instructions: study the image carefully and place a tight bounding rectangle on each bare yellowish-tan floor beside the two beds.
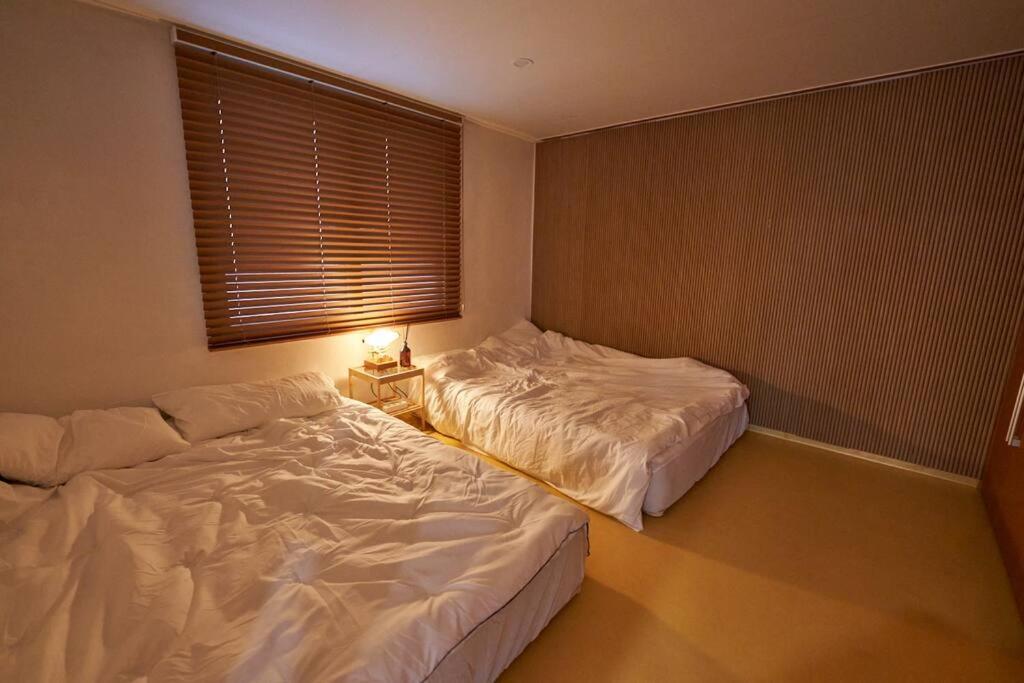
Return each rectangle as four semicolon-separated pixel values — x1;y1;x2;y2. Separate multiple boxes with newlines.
437;432;1024;683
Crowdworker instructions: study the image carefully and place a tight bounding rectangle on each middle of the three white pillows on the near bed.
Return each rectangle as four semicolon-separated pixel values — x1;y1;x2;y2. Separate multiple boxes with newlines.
57;408;188;481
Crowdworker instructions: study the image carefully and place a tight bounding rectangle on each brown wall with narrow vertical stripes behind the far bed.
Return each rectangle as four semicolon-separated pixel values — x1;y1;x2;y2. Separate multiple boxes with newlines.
532;55;1024;476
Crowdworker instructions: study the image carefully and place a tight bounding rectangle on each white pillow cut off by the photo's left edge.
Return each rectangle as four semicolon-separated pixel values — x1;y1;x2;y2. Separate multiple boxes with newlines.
0;413;63;486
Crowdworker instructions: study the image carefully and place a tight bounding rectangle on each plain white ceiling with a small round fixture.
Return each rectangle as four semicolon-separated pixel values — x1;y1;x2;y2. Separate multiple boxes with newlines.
93;0;1024;139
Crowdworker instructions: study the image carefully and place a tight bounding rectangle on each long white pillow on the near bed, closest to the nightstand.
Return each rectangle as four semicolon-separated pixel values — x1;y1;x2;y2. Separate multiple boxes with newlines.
153;372;342;443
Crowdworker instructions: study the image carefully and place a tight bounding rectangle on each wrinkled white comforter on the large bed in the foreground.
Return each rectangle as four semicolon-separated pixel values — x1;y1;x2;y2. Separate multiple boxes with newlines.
0;402;586;681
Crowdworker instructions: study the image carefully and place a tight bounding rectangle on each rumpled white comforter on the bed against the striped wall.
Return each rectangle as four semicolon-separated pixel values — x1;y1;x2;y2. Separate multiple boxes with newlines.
426;323;749;530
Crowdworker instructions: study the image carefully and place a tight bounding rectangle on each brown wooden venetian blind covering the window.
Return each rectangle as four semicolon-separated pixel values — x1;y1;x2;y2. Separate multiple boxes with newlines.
175;34;462;348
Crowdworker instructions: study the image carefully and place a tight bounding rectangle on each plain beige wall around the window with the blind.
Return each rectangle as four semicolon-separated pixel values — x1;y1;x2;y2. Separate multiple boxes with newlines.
0;0;534;415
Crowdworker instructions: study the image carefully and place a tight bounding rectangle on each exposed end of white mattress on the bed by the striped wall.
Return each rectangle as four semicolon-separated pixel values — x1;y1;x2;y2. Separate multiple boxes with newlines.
643;404;749;517
